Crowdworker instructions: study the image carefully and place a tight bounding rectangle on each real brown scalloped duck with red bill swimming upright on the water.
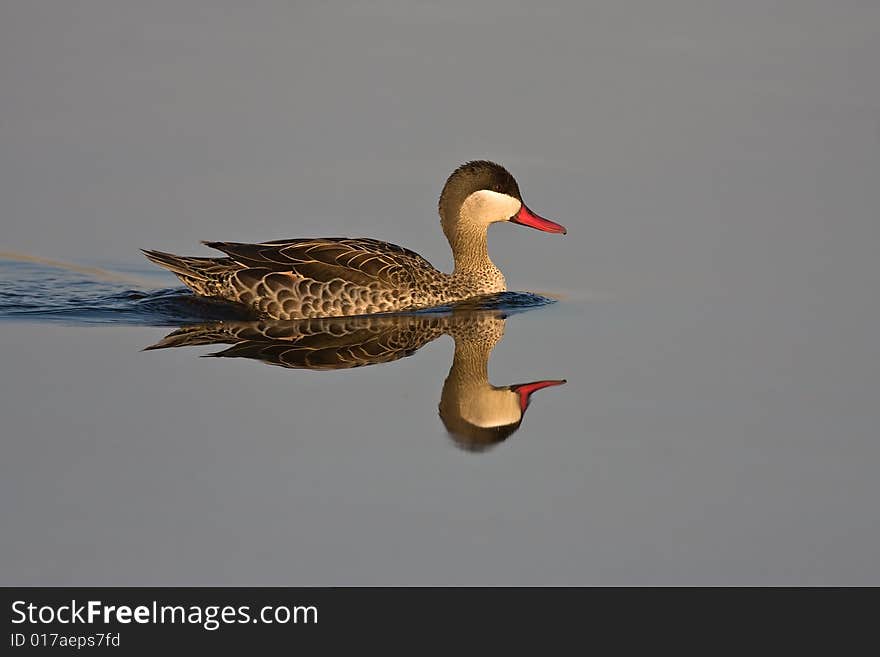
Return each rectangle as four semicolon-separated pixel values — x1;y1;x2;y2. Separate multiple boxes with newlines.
142;160;567;320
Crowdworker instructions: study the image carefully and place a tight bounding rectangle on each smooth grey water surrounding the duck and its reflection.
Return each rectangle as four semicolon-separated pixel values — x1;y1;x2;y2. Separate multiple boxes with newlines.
0;0;880;585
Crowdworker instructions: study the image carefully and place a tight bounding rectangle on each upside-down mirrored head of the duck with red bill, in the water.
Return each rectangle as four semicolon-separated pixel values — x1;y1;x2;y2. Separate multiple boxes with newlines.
440;379;565;452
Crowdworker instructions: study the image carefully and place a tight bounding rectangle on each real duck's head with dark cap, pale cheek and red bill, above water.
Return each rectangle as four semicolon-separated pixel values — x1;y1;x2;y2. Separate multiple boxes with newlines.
440;160;567;243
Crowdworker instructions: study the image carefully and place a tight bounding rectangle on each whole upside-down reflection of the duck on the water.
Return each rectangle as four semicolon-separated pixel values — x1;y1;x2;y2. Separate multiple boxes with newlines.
147;310;565;450
